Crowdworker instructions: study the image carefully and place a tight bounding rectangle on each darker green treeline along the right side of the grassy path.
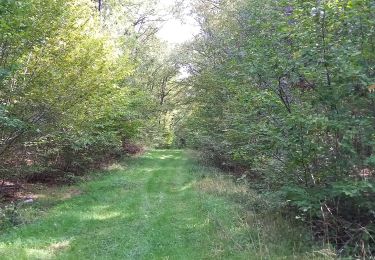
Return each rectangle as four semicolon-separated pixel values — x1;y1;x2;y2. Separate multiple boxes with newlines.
177;0;375;258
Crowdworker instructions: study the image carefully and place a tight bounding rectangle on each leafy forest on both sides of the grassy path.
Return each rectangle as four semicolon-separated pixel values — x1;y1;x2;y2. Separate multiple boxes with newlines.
0;0;375;259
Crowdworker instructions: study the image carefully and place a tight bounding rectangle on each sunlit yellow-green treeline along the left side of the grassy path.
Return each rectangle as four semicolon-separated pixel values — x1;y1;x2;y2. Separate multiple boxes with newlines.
0;0;178;181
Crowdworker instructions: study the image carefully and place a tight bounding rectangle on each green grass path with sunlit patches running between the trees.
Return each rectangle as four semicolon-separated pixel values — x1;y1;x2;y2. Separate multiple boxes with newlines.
0;150;334;259
